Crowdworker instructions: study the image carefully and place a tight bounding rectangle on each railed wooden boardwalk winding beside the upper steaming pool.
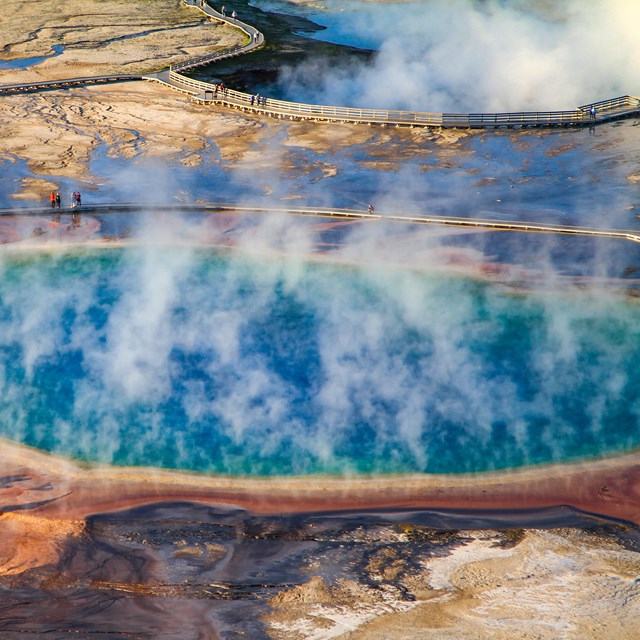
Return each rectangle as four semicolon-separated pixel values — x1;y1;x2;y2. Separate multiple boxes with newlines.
0;0;640;129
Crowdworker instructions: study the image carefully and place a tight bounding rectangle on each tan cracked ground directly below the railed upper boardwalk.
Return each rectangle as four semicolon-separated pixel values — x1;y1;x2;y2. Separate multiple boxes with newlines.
0;81;470;200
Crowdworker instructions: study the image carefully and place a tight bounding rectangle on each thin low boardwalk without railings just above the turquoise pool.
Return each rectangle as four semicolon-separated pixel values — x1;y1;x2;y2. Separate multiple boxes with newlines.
0;203;640;243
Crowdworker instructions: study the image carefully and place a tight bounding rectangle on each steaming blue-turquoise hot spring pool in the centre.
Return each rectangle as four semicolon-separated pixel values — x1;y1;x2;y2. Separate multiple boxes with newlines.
0;248;640;475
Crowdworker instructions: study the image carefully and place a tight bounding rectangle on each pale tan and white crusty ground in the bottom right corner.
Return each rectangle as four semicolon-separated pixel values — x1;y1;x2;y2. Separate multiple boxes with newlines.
267;529;640;640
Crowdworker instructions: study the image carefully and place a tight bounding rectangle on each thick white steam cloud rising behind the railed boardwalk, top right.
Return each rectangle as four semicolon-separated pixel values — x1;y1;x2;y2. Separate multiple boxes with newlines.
274;0;640;113
